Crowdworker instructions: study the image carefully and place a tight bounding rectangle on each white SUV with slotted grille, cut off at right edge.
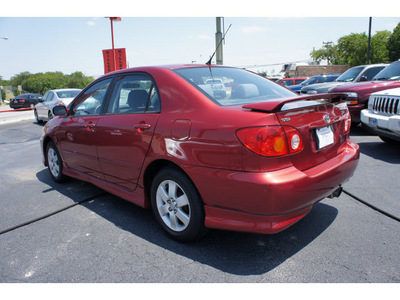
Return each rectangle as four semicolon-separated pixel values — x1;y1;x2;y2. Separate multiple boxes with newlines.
361;88;400;143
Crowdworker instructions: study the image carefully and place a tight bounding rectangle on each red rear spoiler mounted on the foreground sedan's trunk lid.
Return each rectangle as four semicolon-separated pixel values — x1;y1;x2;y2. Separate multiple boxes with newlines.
242;93;347;113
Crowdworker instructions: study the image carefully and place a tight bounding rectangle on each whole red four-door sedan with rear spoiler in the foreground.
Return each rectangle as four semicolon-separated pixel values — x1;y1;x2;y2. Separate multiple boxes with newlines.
41;65;359;241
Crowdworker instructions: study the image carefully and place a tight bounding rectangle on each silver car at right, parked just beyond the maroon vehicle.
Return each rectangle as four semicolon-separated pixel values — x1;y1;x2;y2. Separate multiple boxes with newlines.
300;64;389;94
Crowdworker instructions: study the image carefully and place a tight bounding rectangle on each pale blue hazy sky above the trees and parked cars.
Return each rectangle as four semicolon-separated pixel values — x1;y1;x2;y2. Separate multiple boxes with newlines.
0;0;400;79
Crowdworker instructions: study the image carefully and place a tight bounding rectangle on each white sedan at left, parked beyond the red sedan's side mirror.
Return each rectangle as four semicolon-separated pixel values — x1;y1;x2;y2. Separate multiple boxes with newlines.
34;89;82;123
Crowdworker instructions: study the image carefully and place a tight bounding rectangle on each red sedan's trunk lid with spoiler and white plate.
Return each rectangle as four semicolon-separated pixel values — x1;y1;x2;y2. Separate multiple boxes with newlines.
243;94;349;171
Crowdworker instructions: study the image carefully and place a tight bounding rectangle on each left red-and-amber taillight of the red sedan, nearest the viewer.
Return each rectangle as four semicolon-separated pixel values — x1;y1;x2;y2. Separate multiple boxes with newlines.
236;126;303;156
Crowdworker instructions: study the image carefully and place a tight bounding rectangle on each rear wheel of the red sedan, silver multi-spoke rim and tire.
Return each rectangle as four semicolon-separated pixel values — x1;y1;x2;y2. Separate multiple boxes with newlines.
151;167;206;242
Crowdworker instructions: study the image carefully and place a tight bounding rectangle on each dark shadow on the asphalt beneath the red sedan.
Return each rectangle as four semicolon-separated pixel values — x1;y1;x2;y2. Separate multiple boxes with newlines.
37;172;338;275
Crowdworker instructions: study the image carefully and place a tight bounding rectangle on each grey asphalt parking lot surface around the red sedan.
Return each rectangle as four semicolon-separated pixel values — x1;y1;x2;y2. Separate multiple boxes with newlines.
0;106;400;283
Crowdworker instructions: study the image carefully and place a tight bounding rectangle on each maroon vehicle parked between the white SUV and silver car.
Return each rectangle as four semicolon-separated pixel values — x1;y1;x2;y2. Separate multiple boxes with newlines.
329;60;400;123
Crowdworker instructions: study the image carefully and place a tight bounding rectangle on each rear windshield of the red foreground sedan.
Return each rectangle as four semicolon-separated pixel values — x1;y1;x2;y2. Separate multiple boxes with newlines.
174;67;297;106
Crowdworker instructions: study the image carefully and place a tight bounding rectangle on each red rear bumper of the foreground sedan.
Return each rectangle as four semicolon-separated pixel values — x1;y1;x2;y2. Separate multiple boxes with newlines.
185;140;359;234
